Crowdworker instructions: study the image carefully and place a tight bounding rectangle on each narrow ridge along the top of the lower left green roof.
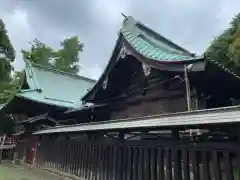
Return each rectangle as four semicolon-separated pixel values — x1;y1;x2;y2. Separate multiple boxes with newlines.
24;60;96;82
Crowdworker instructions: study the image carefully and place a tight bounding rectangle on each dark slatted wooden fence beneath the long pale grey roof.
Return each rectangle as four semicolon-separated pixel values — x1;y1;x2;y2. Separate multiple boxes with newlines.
33;138;240;180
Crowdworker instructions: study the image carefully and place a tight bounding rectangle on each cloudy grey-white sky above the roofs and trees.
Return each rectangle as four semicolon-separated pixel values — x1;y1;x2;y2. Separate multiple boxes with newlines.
0;0;240;79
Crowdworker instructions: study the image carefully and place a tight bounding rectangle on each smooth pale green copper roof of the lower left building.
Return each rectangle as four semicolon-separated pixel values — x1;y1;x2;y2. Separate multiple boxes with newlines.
17;62;95;108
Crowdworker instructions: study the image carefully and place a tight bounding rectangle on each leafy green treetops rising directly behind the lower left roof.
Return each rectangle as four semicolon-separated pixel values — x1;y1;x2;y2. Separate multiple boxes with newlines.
22;36;83;74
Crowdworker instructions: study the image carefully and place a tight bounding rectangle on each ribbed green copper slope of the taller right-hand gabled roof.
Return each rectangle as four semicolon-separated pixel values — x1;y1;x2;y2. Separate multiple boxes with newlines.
121;16;203;62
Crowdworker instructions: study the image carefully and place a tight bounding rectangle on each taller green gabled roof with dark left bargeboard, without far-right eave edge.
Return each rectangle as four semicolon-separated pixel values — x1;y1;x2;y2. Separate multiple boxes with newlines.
82;16;204;101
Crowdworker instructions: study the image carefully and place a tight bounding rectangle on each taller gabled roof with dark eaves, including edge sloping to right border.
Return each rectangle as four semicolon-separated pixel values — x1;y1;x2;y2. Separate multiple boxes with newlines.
82;16;240;102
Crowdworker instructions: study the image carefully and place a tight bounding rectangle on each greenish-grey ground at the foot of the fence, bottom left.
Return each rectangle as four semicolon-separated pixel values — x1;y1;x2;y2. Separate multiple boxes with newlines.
0;164;70;180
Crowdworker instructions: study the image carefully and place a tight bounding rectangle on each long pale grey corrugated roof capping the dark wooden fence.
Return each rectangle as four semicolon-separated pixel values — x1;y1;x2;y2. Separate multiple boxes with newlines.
34;106;240;134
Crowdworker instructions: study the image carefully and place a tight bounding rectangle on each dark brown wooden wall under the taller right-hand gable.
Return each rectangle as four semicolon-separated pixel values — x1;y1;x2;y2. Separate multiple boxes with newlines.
111;70;187;119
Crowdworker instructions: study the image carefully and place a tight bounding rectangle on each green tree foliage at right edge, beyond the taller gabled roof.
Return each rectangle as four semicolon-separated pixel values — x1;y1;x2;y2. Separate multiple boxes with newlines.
206;13;240;74
